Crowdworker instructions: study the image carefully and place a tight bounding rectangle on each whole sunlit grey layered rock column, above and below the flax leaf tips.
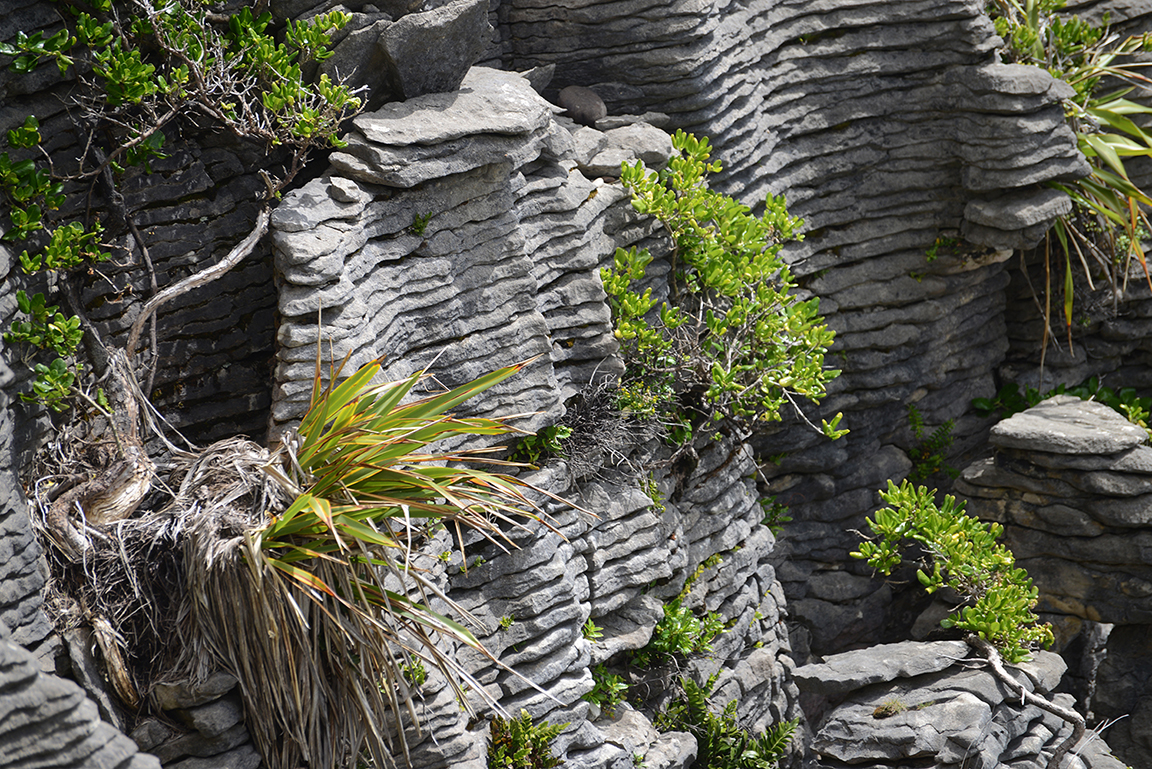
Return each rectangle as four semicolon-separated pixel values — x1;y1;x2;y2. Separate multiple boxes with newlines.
272;67;795;767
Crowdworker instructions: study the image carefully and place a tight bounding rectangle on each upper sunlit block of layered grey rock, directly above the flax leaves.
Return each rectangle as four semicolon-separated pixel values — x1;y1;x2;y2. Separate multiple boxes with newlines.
272;68;645;429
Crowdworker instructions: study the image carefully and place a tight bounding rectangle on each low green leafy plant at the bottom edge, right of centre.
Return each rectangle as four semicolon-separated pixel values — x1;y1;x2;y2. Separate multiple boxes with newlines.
655;676;797;769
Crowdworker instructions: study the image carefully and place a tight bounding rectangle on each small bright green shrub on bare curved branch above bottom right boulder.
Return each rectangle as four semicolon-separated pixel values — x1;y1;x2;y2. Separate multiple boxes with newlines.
851;481;1053;662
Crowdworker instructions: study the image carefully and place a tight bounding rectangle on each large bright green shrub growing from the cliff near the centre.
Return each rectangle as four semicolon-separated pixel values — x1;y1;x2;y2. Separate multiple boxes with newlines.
601;131;847;444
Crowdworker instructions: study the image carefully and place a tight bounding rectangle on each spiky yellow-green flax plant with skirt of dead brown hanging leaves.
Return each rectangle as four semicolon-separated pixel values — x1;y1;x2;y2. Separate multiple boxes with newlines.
190;361;559;769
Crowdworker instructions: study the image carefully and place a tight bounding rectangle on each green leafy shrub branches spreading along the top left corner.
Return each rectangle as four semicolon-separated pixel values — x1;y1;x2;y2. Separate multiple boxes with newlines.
0;0;359;151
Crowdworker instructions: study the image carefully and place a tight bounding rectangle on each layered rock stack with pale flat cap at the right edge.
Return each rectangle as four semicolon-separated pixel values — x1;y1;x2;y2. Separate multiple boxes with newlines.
956;396;1152;766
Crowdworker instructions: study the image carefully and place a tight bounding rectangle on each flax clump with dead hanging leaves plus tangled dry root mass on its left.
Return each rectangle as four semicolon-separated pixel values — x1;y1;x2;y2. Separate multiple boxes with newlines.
31;361;562;769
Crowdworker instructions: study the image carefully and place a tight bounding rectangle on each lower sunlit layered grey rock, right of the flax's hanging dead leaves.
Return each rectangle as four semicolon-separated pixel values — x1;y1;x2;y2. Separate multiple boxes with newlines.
421;443;798;767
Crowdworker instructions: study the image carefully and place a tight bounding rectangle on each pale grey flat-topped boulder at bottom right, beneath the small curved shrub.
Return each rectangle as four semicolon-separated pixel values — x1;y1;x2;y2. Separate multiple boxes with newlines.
796;641;1124;769
